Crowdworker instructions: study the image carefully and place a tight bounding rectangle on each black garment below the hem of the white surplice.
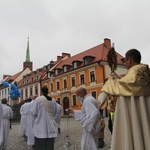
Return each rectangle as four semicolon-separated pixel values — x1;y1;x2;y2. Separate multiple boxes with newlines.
35;137;54;150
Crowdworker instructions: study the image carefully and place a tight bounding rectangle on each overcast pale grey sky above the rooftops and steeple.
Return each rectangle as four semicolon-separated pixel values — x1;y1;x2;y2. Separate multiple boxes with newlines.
0;0;150;80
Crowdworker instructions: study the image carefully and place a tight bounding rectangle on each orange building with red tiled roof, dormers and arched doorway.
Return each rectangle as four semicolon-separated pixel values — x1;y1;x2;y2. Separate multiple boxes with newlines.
41;39;126;114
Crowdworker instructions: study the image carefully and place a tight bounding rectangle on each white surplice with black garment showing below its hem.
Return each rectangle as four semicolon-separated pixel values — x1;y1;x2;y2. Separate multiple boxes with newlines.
30;96;57;138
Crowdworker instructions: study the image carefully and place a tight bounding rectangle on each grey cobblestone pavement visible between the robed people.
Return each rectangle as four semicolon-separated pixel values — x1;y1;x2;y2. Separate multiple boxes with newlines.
7;118;111;150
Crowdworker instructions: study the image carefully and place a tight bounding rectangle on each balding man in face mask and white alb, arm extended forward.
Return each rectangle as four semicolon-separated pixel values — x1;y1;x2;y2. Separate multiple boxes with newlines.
68;87;100;150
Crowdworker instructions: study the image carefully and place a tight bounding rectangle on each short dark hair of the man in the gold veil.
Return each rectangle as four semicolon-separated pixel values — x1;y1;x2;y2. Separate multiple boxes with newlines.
125;49;141;63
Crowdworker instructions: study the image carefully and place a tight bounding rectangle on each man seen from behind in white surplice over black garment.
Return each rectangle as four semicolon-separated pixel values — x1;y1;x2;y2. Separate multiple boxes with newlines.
30;86;57;150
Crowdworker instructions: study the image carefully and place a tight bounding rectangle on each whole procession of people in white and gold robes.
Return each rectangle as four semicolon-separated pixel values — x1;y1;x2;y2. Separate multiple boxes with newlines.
0;49;150;150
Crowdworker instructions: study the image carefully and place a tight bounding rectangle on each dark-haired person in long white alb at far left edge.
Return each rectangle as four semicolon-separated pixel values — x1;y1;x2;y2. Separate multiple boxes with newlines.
0;98;13;150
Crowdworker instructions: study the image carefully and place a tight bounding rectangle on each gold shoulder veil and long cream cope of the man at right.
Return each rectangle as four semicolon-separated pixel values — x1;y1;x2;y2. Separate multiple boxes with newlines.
101;64;150;150
